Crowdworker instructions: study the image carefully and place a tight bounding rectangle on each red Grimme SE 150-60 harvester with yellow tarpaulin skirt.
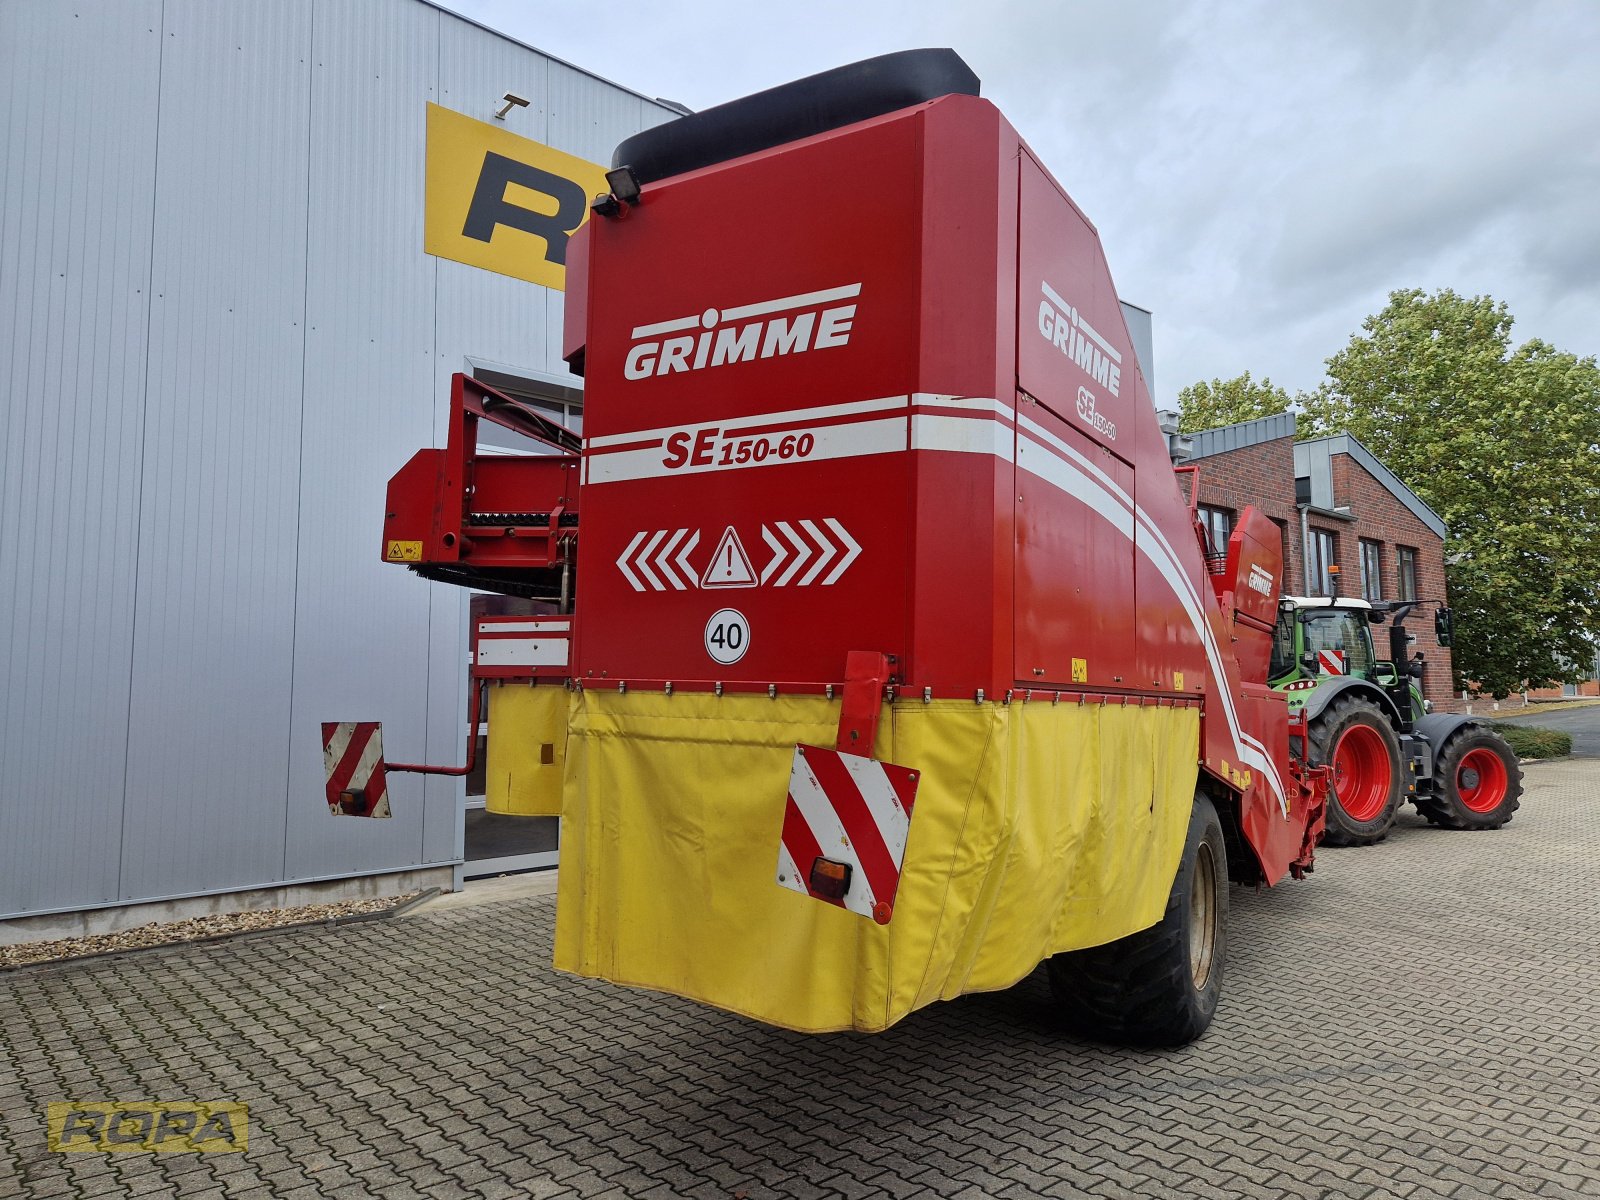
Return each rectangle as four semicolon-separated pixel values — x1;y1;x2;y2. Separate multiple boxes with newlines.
356;50;1478;1043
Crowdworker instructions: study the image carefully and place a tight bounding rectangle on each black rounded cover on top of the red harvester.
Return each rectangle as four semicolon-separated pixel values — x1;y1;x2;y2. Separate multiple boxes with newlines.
611;50;978;184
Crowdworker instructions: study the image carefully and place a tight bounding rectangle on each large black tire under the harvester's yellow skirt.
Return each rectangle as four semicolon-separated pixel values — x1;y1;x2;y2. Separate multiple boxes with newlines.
1048;795;1227;1046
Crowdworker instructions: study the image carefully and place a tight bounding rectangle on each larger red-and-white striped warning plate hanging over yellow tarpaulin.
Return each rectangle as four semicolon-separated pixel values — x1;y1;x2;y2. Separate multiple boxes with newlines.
778;746;918;925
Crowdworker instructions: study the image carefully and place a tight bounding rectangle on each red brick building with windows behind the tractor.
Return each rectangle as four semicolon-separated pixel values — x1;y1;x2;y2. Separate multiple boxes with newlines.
1189;413;1461;712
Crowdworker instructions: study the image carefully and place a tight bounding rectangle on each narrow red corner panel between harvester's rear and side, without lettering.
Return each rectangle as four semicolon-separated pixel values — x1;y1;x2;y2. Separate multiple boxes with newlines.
902;96;1018;696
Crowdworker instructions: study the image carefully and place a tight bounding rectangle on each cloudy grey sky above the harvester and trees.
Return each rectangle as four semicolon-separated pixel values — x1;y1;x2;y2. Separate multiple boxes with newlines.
446;0;1600;403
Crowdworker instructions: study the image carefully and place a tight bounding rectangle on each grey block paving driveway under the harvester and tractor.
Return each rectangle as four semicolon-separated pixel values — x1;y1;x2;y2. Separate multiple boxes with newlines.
0;760;1600;1200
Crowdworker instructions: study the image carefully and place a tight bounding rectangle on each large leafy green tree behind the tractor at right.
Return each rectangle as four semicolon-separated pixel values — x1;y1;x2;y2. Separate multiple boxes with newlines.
1306;288;1600;696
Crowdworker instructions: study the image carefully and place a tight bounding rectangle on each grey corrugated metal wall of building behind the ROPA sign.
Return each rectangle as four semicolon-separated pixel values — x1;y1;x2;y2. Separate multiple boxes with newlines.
0;0;672;917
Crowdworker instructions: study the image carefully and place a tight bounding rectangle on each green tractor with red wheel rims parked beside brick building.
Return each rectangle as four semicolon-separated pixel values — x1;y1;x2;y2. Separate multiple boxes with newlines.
1269;597;1522;846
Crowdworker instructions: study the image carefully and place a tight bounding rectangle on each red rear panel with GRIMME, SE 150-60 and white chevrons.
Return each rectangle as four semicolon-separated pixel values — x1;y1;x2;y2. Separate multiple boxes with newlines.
576;112;922;694
